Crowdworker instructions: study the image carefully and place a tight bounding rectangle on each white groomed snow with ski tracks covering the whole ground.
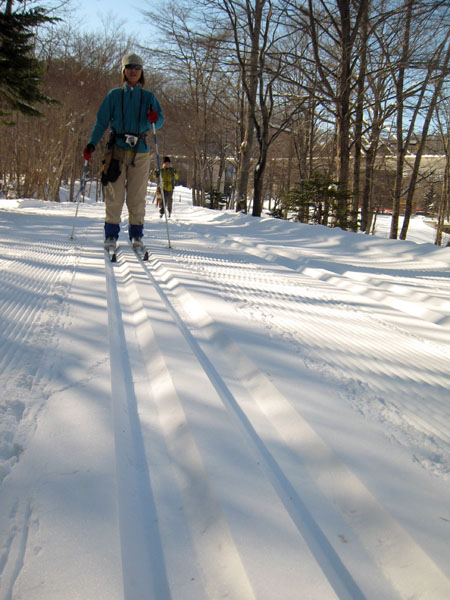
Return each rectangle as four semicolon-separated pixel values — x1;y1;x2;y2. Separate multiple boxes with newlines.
0;187;450;600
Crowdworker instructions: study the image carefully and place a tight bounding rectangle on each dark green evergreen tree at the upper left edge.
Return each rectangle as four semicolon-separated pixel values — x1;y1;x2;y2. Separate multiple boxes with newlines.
0;0;54;125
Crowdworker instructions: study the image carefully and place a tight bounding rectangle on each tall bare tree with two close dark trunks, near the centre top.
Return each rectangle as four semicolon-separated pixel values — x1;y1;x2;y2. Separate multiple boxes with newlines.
206;0;308;216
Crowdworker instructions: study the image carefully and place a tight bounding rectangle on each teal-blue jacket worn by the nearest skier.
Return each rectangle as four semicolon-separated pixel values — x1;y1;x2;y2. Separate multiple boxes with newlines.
89;83;164;153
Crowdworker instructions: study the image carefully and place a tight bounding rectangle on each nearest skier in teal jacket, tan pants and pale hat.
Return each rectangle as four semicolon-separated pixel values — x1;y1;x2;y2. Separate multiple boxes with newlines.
83;54;164;247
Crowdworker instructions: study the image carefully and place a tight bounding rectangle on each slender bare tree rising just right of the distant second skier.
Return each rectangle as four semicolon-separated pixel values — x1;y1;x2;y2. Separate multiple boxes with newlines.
145;3;234;206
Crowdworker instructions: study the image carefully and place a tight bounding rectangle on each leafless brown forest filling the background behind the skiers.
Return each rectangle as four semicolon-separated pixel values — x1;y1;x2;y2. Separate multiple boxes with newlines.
0;0;450;245
